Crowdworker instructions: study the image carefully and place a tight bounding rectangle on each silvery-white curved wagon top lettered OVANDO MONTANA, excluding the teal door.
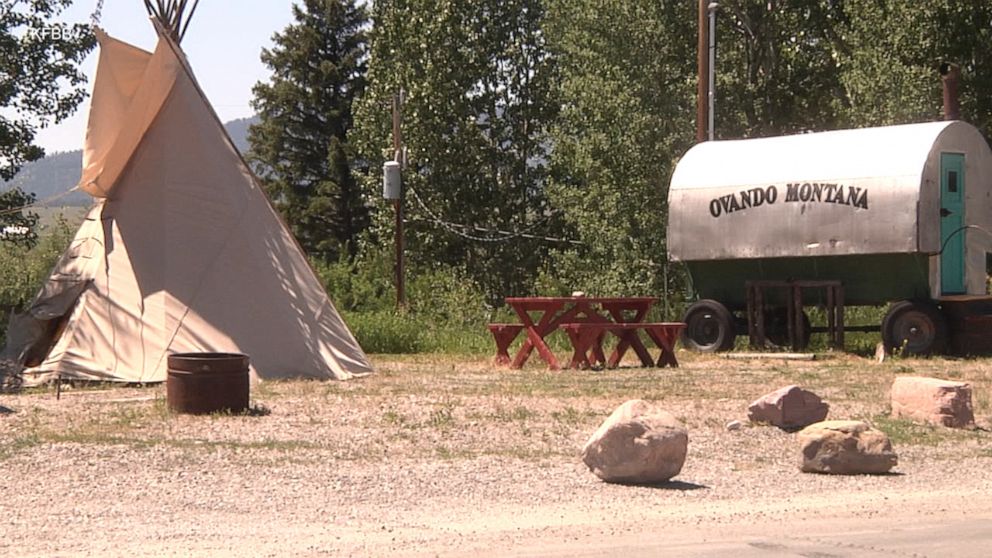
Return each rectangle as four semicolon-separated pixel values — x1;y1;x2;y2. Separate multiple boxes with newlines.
668;121;992;265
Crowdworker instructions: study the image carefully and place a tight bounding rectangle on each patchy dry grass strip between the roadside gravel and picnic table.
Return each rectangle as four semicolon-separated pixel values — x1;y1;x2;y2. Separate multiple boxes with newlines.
0;351;992;464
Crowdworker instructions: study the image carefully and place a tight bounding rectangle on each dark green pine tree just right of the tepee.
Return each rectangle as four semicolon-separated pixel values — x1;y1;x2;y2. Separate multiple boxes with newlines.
249;0;368;261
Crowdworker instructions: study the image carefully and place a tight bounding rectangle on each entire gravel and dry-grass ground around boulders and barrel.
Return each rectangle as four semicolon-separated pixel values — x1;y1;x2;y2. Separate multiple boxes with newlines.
0;352;992;557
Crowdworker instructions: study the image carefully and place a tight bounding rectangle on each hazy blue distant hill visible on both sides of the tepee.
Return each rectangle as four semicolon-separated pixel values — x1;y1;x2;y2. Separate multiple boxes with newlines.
0;117;258;206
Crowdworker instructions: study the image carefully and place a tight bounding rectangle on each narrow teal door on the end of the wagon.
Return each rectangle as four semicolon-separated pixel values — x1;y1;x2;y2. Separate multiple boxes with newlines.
940;153;965;295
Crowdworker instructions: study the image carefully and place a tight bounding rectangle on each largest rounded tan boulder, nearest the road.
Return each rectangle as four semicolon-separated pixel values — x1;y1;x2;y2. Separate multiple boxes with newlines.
582;399;689;484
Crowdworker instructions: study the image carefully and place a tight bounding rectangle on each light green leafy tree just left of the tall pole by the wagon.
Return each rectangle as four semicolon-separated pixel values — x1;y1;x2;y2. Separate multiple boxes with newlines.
548;0;695;295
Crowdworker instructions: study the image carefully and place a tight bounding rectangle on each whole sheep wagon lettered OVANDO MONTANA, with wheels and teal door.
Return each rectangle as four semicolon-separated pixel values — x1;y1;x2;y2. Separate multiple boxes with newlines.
668;121;992;354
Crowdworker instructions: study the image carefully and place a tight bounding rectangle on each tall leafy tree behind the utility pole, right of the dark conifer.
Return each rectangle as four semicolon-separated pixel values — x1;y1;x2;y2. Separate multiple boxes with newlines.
357;0;558;300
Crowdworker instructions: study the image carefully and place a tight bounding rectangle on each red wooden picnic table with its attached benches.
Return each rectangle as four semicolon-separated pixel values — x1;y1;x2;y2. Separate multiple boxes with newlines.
489;296;685;370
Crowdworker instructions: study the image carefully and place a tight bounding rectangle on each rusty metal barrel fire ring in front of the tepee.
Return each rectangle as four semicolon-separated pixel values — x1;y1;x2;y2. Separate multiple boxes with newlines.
165;353;249;415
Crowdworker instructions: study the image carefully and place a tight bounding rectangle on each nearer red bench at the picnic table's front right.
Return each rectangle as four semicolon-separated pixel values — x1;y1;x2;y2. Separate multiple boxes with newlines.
559;322;685;368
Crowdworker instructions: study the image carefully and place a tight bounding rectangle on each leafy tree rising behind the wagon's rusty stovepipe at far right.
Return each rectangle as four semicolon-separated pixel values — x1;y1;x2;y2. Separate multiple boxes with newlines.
840;0;992;137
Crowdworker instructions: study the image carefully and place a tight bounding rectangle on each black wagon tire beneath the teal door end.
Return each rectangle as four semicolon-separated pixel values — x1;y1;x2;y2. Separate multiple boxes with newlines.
882;300;948;355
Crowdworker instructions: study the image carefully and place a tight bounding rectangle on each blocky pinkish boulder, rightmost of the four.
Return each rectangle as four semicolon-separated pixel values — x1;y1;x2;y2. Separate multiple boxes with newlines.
891;376;975;428
